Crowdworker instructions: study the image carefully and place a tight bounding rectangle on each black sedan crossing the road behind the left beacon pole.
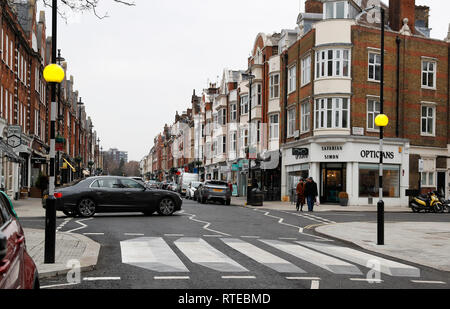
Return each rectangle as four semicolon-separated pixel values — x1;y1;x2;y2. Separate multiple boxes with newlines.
43;176;183;218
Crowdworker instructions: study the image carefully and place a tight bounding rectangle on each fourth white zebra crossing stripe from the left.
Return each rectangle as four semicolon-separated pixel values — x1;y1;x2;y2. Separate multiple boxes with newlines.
260;240;362;275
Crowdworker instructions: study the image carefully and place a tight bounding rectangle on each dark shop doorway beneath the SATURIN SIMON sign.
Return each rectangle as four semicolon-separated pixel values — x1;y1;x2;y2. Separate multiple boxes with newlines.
321;163;347;203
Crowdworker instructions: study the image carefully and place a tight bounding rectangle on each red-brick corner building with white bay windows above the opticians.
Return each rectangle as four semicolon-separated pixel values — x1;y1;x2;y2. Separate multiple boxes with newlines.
281;0;449;205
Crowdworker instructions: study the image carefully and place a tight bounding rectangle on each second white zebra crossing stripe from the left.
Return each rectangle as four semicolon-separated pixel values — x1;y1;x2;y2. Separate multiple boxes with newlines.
175;237;248;272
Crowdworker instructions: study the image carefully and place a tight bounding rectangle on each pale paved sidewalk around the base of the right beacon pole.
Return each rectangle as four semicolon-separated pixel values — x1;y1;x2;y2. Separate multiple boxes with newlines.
315;222;450;271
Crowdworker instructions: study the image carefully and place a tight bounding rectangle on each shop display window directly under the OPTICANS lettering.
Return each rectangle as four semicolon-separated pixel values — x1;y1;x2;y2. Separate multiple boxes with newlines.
359;164;400;198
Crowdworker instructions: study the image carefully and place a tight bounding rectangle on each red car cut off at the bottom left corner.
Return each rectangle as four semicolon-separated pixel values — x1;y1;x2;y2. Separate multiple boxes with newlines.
0;191;39;289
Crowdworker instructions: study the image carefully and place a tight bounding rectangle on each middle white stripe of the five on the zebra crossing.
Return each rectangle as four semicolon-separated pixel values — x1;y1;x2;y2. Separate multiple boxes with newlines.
222;238;305;273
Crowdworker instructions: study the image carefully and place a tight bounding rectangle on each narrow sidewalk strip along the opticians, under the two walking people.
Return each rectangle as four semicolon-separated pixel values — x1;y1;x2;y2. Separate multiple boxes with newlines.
231;196;411;212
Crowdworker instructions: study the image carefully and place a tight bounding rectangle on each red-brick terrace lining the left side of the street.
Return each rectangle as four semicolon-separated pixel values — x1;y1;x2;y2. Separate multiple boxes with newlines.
0;0;97;198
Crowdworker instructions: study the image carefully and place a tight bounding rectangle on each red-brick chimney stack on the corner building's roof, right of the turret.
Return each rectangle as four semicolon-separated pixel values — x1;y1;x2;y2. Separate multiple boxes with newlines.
389;0;416;33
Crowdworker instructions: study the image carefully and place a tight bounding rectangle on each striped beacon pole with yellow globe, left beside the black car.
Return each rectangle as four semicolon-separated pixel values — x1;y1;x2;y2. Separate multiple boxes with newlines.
43;0;64;264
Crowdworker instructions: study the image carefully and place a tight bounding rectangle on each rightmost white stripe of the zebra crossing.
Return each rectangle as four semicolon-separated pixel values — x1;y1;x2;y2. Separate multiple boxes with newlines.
297;241;420;277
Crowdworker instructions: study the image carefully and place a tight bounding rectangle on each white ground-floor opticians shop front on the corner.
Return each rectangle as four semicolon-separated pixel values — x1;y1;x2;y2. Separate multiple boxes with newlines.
282;137;409;206
